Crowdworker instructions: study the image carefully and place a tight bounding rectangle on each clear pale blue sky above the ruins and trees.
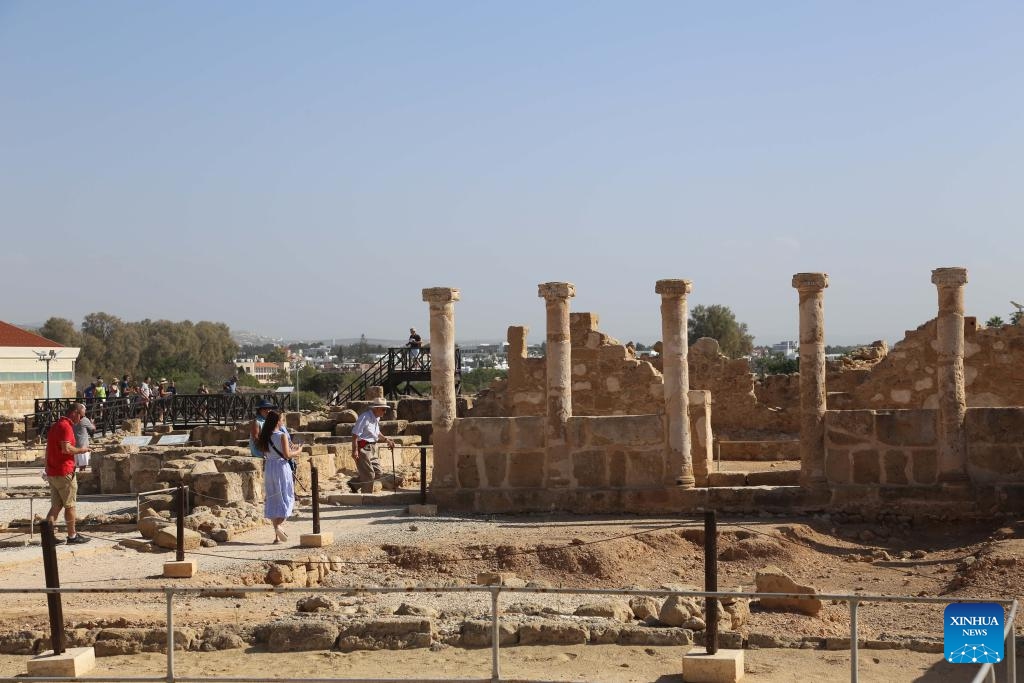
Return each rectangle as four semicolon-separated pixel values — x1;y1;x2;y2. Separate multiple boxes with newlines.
0;0;1024;343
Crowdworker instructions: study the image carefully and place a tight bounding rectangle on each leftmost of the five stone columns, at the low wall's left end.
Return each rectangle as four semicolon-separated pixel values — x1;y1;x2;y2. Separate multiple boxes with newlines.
423;287;460;488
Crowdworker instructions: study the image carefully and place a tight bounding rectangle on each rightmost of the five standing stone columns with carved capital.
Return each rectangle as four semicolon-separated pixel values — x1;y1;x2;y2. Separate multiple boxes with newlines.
932;268;967;481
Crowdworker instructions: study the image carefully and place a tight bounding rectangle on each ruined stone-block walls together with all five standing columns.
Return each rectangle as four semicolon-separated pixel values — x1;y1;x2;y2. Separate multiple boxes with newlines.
413;268;1024;514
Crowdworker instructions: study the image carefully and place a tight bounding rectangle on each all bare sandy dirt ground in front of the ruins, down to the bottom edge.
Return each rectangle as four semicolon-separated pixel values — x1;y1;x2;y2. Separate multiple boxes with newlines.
0;473;1024;681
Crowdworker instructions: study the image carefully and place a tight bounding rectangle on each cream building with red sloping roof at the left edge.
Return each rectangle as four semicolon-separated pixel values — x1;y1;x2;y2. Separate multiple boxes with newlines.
0;321;82;417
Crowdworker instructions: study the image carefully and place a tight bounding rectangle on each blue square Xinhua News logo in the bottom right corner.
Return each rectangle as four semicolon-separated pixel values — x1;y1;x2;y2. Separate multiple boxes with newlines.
942;602;1004;664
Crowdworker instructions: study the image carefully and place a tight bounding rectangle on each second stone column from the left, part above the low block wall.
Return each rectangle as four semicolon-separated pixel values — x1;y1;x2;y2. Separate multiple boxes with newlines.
537;283;575;443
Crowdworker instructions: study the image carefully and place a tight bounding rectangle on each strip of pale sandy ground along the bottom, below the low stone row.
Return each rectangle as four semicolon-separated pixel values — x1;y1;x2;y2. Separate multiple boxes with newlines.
0;645;1024;683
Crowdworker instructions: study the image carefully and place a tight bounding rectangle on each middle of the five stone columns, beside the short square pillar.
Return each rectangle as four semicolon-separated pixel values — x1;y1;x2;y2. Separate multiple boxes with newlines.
654;280;707;488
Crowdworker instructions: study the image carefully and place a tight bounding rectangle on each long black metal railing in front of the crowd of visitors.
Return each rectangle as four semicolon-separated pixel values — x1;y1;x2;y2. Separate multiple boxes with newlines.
25;393;291;435
